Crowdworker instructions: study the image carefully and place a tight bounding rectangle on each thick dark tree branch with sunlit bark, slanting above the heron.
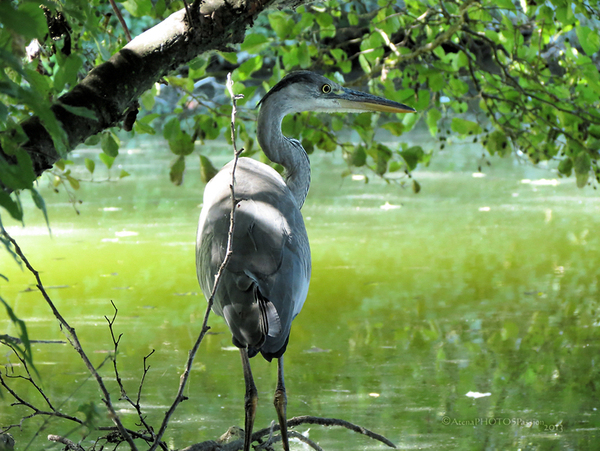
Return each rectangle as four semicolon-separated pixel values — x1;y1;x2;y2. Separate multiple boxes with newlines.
7;0;303;184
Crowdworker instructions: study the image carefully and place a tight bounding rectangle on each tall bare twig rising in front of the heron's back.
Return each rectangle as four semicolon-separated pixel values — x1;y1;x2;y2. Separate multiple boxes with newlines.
149;74;243;451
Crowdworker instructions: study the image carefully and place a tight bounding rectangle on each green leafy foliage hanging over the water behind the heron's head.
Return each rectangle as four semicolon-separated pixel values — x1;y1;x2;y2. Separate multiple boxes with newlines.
0;0;600;224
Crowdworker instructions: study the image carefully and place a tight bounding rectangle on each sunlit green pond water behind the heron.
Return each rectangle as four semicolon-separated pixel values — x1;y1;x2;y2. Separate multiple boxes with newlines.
0;135;600;450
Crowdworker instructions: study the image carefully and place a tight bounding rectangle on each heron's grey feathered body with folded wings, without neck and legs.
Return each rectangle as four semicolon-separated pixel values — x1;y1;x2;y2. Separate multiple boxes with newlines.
196;158;311;360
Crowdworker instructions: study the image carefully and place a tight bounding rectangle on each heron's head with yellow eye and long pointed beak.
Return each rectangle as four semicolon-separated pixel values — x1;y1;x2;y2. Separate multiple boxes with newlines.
260;71;415;115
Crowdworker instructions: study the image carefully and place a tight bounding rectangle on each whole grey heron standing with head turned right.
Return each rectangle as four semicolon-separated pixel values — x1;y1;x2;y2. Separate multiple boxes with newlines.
196;71;415;451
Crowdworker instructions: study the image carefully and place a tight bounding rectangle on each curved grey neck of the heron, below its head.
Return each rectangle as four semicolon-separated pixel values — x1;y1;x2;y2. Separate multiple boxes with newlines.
256;96;310;208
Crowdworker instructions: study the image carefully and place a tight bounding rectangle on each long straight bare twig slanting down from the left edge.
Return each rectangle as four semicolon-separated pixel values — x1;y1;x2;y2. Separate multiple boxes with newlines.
2;230;137;451
